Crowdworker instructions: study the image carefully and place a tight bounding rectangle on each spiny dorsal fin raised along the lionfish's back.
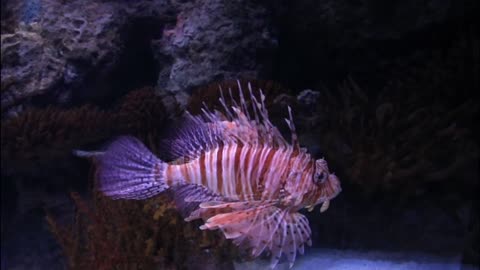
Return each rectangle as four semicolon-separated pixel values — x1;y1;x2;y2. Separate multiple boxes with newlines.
164;81;299;160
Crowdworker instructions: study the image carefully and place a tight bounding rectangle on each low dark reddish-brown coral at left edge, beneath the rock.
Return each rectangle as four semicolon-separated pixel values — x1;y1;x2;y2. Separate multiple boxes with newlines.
1;105;112;172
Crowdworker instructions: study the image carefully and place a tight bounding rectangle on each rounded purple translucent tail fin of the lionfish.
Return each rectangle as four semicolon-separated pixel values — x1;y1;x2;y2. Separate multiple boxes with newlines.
96;136;168;200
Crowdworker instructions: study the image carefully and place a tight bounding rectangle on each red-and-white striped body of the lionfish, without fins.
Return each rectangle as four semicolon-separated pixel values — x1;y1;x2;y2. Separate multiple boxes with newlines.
165;144;314;205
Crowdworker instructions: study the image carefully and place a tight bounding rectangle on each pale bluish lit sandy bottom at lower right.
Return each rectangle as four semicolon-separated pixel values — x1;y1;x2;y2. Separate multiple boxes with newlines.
235;249;479;270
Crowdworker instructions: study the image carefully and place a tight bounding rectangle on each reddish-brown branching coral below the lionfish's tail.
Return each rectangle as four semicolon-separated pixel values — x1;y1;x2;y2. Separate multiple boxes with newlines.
47;176;235;269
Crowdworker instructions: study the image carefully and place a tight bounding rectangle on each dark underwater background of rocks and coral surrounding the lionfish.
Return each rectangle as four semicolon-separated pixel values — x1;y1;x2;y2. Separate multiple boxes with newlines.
1;0;480;269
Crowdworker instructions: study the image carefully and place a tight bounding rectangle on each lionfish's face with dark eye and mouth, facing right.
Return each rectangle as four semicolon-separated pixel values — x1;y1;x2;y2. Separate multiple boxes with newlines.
307;158;342;212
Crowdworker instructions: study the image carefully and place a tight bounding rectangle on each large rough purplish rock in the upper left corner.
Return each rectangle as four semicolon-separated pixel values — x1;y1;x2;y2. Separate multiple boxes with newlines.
1;0;172;114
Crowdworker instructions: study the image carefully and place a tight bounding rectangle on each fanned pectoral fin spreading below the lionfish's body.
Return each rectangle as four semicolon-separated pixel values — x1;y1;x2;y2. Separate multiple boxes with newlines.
200;204;312;268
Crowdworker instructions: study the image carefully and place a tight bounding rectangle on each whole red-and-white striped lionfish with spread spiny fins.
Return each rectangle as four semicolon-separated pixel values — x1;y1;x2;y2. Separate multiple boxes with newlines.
97;82;341;268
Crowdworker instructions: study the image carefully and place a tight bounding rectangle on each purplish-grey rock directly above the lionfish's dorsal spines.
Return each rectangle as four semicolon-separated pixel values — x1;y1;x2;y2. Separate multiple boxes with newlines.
155;0;277;105
